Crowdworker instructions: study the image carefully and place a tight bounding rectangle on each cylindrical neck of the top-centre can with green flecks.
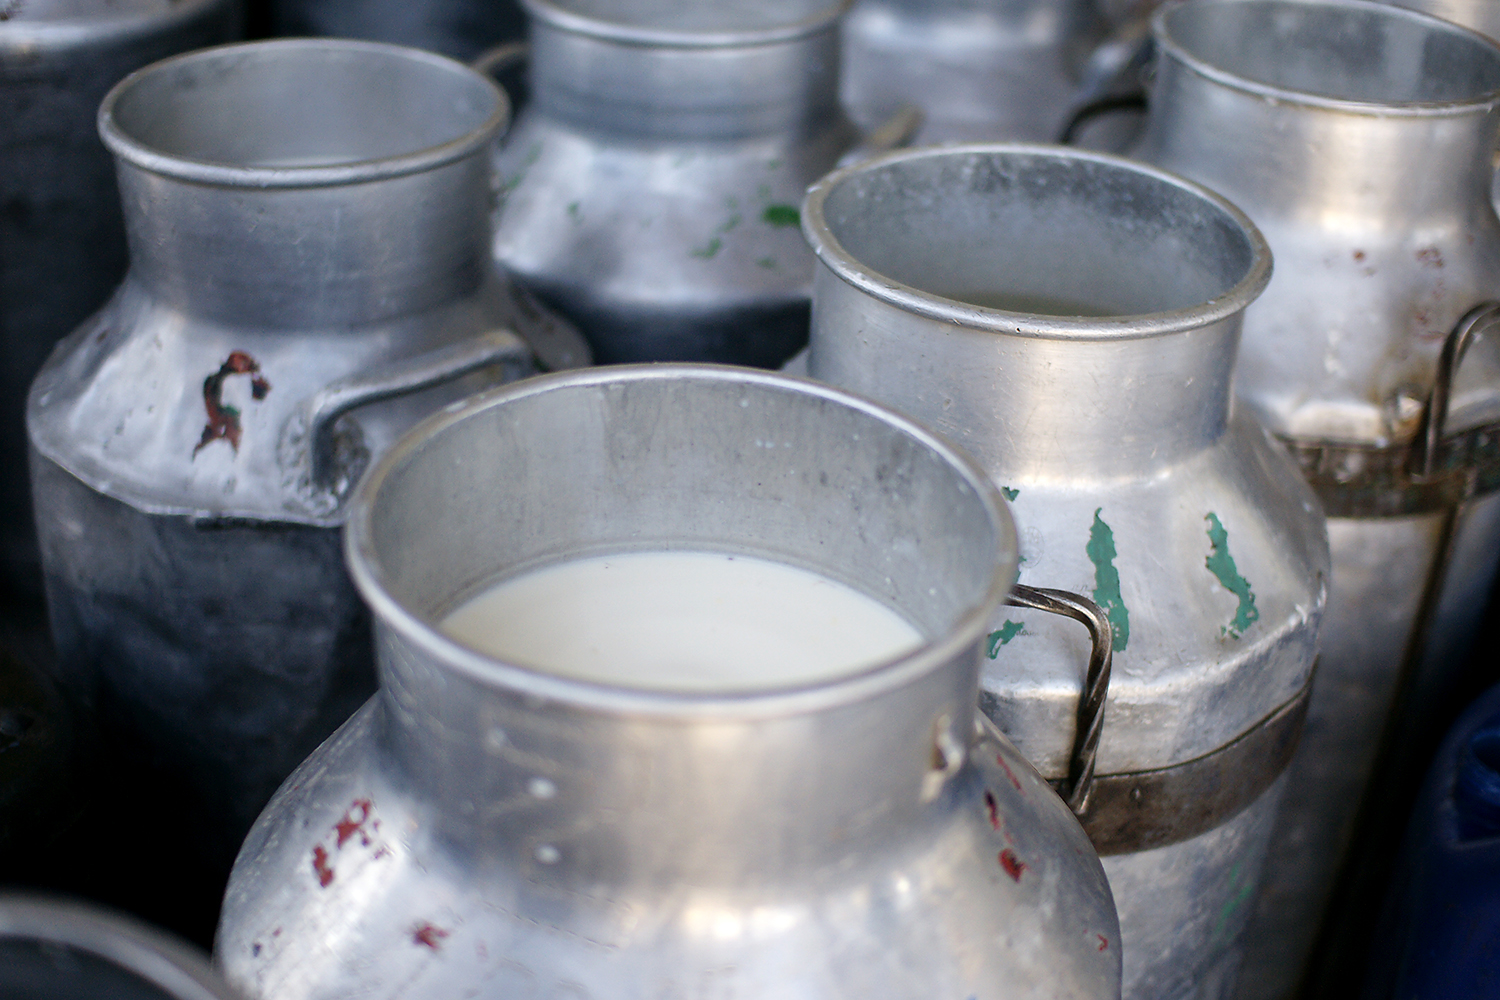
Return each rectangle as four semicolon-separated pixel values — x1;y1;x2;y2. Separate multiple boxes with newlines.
531;12;842;141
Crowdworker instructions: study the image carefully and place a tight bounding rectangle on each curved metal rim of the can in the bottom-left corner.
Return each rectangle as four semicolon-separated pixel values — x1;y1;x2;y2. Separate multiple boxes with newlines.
0;892;237;1000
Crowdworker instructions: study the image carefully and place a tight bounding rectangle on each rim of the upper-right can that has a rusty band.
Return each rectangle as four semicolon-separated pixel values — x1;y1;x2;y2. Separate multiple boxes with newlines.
1151;0;1500;118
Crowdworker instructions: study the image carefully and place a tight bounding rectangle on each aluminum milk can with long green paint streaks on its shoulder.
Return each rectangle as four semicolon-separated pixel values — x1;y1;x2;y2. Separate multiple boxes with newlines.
804;145;1328;1000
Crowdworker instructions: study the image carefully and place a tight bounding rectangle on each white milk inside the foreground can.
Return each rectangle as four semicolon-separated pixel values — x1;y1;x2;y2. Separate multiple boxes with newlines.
441;552;923;691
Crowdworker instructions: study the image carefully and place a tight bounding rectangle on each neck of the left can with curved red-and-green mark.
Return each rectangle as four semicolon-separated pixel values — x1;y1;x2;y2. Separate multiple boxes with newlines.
119;154;489;331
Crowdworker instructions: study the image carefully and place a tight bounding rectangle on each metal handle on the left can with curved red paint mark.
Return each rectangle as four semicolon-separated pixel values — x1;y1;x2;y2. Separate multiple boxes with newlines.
300;330;531;492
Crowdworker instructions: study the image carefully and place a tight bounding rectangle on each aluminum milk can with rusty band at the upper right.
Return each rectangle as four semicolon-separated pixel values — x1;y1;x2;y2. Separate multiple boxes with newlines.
1137;0;1500;997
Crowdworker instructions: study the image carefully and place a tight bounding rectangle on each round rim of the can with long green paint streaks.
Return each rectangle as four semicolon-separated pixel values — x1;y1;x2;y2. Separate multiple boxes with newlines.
803;142;1272;340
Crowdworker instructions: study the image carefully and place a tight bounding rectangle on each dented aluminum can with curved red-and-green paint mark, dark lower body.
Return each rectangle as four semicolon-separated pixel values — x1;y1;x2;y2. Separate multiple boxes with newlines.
29;40;585;871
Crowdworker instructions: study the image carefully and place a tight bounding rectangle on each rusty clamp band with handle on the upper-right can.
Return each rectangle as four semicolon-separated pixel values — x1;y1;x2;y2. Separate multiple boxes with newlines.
1281;301;1500;517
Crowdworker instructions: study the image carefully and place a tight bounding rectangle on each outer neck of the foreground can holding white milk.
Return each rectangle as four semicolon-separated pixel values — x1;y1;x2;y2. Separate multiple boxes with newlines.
380;638;977;891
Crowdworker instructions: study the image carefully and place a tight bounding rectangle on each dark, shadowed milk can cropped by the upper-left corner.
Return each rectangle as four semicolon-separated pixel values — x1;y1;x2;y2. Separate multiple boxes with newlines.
0;0;239;597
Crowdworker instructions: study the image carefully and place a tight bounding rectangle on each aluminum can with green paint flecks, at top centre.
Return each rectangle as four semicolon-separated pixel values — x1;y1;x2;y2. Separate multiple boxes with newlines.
495;0;915;367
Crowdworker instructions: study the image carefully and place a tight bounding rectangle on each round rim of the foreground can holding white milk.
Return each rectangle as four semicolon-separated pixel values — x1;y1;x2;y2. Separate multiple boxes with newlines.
344;363;1019;718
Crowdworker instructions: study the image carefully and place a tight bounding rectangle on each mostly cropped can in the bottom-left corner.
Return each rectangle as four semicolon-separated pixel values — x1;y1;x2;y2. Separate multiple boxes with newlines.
0;894;240;1000
